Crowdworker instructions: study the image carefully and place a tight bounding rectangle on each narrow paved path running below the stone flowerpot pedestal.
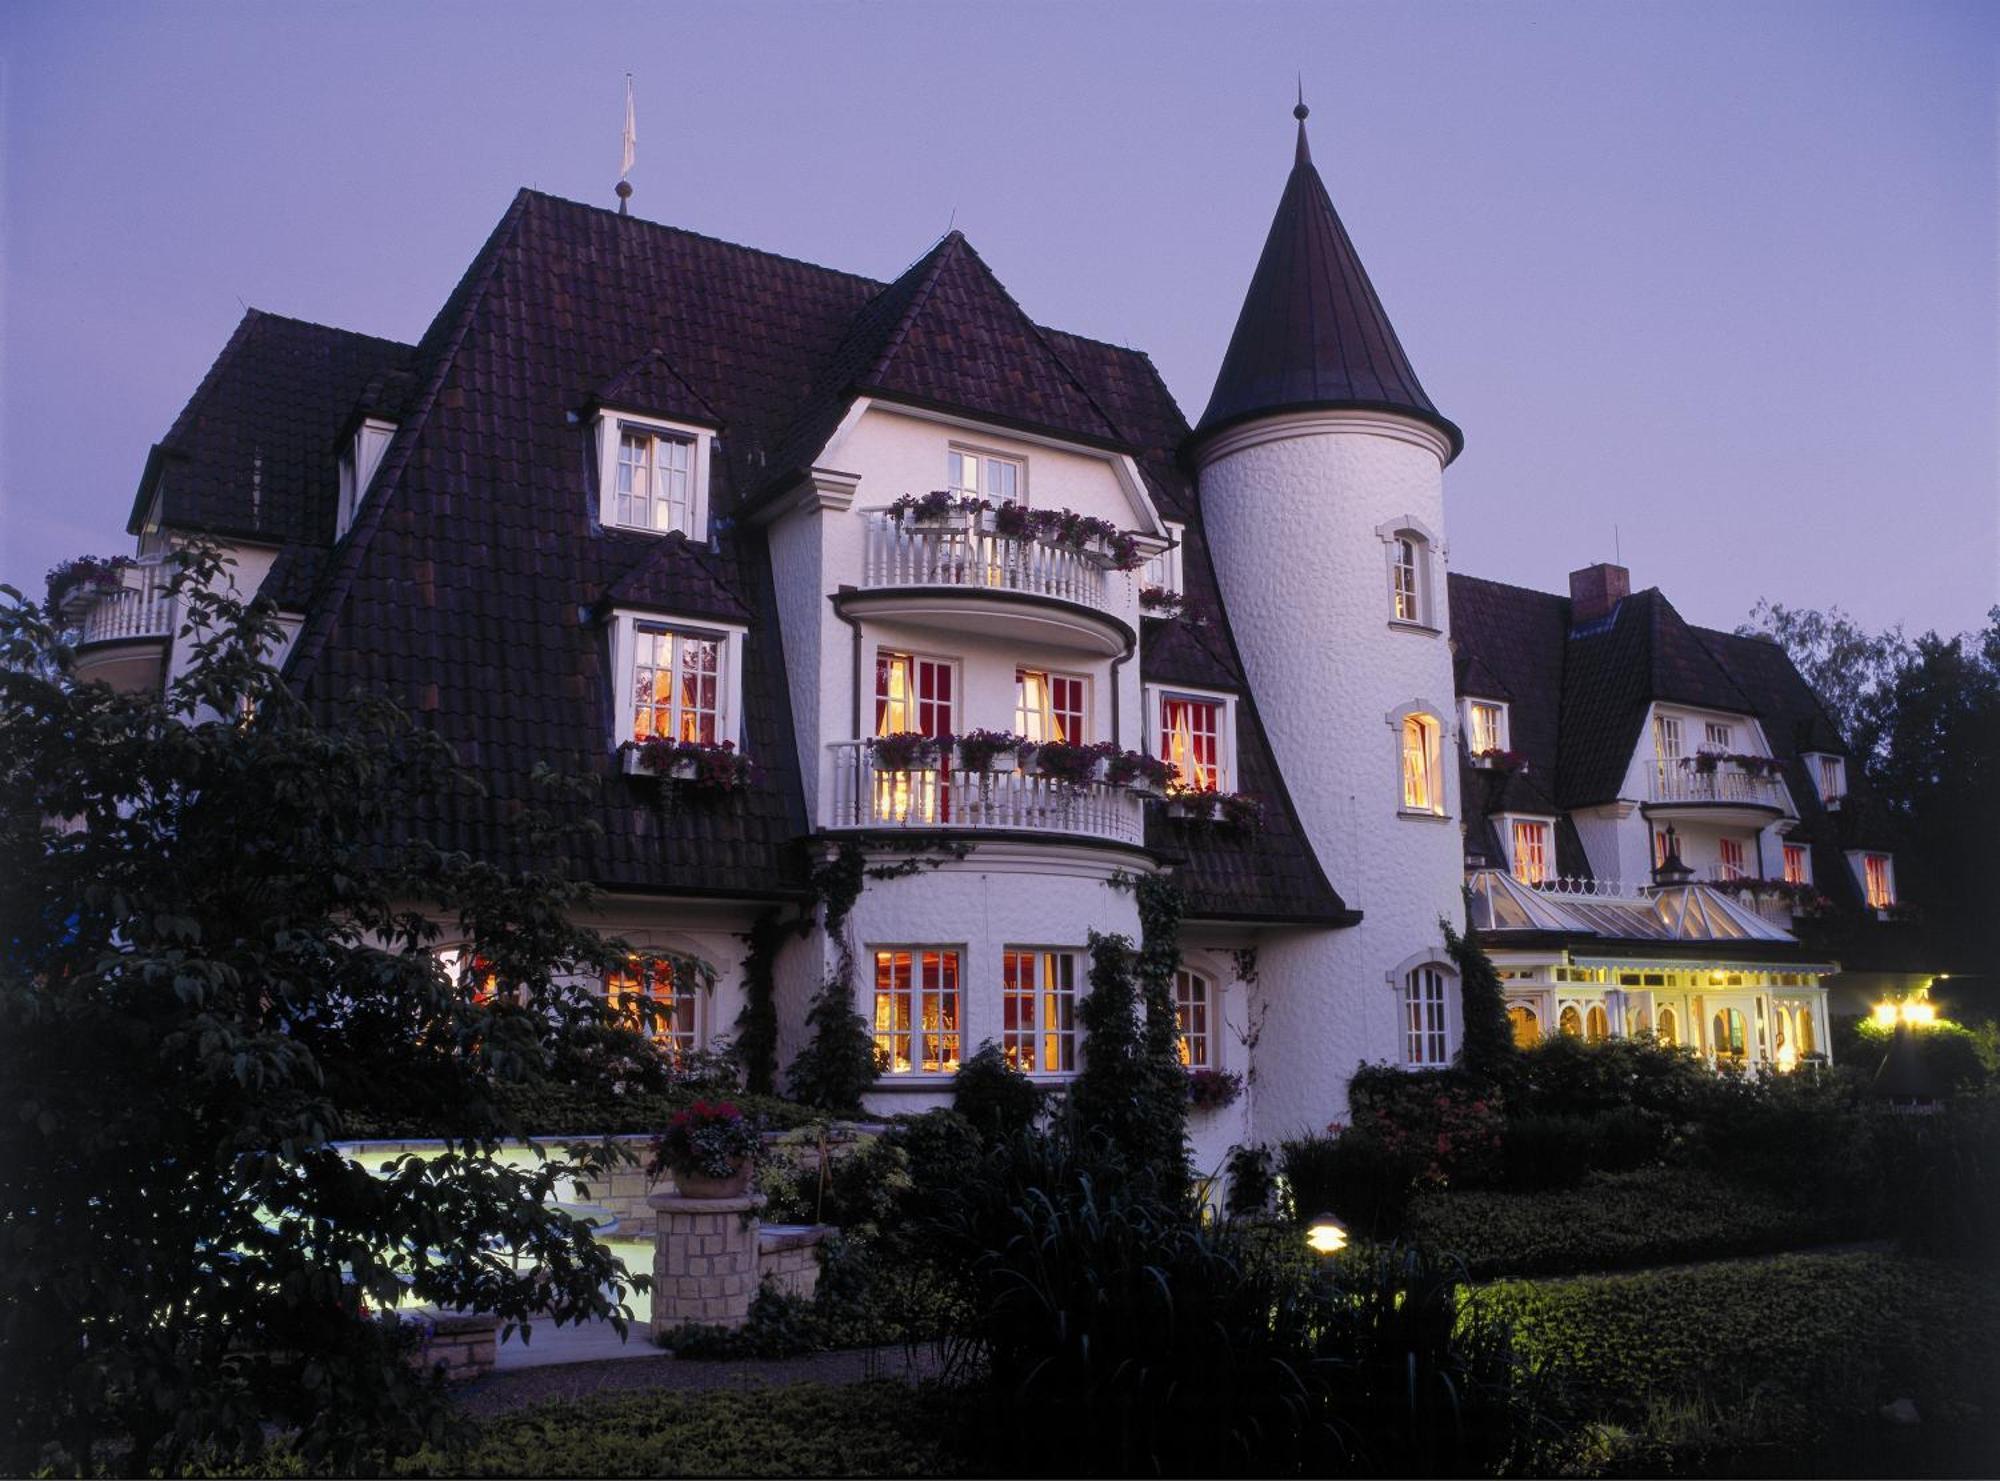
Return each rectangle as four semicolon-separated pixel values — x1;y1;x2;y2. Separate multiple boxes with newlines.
460;1327;942;1415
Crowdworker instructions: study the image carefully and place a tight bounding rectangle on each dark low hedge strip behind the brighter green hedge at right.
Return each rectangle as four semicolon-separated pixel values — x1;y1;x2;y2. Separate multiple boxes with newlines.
1410;1167;1846;1281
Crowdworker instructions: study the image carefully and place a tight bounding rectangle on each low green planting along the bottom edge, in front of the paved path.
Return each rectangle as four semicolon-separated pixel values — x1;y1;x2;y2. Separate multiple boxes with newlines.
394;1379;968;1477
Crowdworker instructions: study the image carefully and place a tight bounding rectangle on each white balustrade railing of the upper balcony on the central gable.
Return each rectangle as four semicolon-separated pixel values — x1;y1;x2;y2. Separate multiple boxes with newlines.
862;510;1112;612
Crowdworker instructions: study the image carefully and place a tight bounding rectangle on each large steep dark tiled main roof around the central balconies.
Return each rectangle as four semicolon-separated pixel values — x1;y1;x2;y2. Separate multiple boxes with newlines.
270;192;1346;921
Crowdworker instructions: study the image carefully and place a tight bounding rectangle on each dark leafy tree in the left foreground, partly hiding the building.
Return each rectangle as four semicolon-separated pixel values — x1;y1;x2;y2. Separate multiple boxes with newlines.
0;548;628;1475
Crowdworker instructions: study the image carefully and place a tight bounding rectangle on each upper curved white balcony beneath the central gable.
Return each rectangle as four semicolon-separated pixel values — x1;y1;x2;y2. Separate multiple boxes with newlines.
842;510;1134;656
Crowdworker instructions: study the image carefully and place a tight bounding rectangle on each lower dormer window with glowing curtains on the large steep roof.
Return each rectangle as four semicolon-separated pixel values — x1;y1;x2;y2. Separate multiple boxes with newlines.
612;612;744;747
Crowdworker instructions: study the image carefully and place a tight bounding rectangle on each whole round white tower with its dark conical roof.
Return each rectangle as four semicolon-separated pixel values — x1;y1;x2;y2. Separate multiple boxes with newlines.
1190;102;1464;1137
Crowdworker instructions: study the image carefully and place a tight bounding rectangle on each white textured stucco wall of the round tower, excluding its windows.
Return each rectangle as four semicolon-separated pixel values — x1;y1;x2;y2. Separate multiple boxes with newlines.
1200;412;1464;1139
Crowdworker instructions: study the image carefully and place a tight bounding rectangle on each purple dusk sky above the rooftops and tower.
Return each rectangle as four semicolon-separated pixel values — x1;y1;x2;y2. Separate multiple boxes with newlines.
0;0;2000;630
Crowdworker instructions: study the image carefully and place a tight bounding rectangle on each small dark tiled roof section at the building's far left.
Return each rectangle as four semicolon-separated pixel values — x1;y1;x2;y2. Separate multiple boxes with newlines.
128;308;412;544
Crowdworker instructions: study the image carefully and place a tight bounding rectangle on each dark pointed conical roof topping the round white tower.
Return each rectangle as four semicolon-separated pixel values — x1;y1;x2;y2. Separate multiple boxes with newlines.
1194;98;1464;458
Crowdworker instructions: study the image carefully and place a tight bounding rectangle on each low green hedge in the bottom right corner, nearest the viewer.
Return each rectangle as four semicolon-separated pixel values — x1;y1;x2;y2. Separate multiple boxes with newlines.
1480;1253;2000;1435
